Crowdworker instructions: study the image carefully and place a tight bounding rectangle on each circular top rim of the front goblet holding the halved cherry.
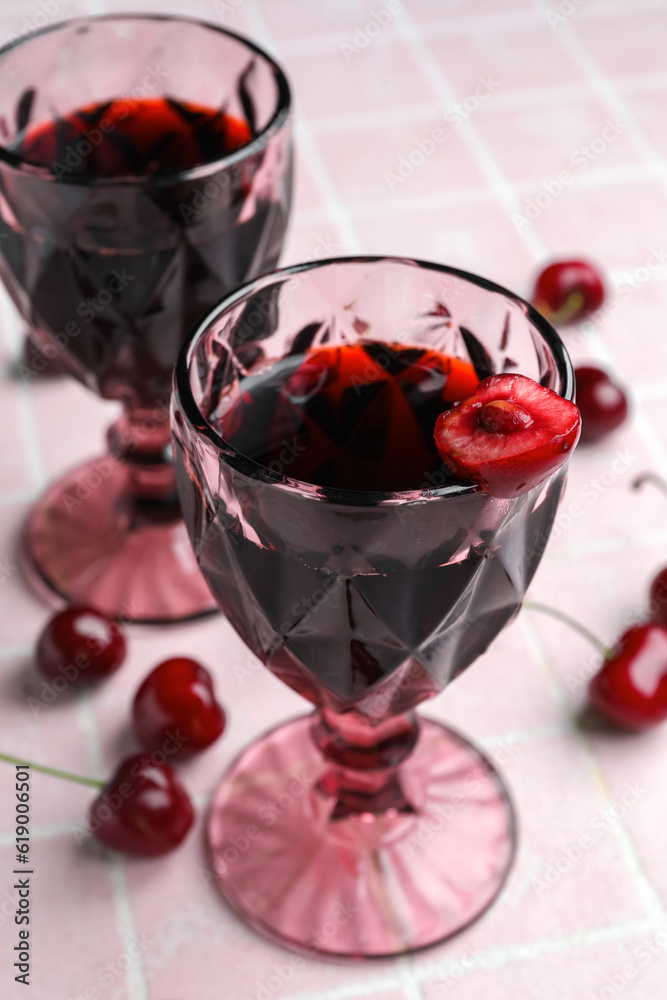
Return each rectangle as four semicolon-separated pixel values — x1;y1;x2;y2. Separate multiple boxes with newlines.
172;255;575;507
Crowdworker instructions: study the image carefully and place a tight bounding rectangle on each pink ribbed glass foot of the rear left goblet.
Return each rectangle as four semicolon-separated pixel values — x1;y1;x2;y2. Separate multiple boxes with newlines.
24;456;217;624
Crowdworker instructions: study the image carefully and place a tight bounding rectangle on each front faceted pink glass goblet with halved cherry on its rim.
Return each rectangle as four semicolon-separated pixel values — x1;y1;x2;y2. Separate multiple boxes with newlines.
172;258;574;958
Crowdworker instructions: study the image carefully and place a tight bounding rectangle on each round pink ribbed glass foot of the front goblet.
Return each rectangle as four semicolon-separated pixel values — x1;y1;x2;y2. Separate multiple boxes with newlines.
208;717;516;959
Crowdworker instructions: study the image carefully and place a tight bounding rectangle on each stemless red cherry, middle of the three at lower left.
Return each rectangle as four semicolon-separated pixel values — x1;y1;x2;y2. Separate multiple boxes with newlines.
132;656;225;756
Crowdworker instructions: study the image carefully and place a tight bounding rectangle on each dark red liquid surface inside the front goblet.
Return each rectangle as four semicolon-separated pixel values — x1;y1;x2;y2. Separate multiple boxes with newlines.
218;341;479;491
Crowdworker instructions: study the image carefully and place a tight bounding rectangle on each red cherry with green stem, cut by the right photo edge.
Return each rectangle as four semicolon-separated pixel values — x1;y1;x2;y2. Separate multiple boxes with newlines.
588;625;667;729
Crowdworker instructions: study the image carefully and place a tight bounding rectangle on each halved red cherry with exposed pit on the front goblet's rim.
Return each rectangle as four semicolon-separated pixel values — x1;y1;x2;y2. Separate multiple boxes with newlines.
435;374;580;498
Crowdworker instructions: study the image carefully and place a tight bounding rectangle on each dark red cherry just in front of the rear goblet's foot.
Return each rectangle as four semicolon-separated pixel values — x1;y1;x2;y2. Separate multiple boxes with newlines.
35;605;127;682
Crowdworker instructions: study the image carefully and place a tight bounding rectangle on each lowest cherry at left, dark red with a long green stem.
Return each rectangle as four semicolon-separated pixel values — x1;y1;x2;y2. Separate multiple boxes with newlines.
88;754;194;858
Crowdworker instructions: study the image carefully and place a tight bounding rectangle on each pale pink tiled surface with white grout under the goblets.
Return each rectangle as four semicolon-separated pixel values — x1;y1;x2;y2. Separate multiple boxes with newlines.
0;0;667;1000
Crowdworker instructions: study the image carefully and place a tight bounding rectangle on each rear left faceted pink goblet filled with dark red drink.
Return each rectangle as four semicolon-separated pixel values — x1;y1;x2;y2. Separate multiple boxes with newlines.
0;14;292;622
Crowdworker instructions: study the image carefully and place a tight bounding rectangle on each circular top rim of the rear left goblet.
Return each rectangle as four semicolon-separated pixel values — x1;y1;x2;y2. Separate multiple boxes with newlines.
0;12;292;187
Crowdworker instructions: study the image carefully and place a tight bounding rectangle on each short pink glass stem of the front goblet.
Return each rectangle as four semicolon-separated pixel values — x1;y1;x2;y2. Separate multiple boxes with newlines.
312;709;419;819
